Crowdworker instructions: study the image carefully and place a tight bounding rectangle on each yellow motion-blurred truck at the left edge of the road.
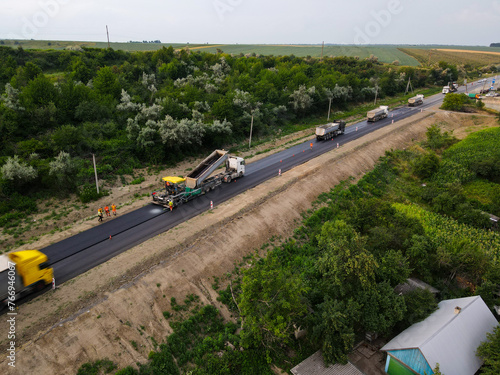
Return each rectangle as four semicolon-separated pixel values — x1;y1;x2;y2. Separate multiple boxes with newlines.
0;250;54;304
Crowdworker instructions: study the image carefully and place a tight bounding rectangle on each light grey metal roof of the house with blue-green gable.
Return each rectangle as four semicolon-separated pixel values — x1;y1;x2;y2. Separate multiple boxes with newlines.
381;296;498;375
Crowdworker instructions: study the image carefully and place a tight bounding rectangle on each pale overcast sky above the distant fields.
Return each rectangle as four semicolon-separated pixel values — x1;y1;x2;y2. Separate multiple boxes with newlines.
0;0;500;46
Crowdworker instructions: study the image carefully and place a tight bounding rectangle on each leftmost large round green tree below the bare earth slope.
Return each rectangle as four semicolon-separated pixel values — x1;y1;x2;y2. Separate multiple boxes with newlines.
239;253;308;349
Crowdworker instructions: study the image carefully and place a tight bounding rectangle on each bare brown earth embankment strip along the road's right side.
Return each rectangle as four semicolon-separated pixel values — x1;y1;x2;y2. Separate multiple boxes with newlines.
0;111;498;375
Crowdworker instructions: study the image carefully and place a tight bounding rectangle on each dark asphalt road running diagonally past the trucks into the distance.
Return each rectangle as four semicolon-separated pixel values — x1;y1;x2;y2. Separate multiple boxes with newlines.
41;81;476;284
